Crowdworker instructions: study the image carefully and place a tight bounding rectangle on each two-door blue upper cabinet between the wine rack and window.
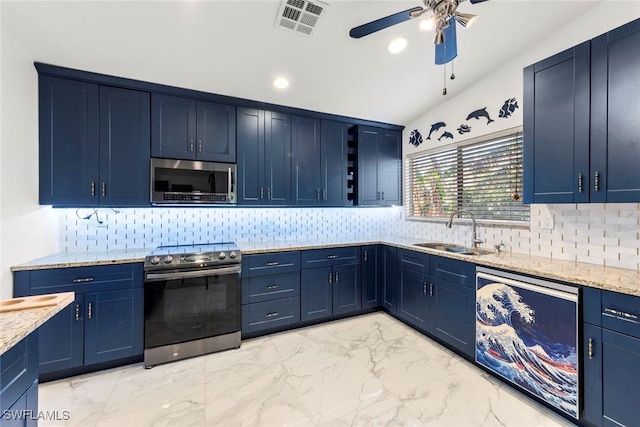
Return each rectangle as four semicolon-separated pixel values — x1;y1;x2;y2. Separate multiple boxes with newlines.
357;126;402;206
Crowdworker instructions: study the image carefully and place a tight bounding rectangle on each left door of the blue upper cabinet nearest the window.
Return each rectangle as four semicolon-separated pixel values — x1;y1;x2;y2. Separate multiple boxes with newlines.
358;126;381;206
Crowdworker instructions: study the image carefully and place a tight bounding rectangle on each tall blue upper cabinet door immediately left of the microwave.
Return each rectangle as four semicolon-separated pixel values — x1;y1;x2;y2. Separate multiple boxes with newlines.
97;86;151;206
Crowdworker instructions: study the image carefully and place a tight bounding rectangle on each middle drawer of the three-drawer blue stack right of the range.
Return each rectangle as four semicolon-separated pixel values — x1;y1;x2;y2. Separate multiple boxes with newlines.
242;272;300;304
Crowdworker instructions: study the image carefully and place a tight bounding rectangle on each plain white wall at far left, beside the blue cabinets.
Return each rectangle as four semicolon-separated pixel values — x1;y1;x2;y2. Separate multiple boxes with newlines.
0;20;59;299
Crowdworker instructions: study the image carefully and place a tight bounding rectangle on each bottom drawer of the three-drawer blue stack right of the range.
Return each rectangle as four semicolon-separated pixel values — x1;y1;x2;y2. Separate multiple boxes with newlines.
242;297;300;333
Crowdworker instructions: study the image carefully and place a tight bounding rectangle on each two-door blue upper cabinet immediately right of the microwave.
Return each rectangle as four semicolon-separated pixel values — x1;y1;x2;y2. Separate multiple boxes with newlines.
237;108;291;205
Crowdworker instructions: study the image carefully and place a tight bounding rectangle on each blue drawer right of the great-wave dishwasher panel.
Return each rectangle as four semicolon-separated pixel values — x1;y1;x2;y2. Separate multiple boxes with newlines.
601;291;640;338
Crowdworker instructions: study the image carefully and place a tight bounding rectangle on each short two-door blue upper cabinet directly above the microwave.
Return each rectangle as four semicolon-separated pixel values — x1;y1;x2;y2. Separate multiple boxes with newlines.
151;93;236;163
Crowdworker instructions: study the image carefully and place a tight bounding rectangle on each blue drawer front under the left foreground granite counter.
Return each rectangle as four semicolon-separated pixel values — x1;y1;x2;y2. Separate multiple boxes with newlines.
0;332;38;419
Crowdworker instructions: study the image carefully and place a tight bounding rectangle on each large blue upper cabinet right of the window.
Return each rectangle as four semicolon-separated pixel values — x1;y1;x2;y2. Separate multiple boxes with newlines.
524;20;640;203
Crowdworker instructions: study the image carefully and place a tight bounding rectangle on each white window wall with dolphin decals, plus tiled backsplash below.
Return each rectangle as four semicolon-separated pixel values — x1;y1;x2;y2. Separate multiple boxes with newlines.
401;1;640;270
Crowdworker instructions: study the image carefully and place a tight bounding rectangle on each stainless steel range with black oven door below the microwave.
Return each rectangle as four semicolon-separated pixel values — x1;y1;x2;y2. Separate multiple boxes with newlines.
144;243;242;368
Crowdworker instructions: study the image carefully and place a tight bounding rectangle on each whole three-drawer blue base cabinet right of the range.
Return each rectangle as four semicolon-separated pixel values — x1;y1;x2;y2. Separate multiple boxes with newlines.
242;251;300;336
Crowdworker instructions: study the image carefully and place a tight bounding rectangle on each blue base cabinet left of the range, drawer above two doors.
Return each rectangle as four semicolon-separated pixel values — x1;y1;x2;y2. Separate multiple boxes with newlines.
14;263;144;379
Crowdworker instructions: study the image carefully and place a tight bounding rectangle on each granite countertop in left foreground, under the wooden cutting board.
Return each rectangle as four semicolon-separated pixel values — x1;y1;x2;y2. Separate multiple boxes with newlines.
0;292;75;355
